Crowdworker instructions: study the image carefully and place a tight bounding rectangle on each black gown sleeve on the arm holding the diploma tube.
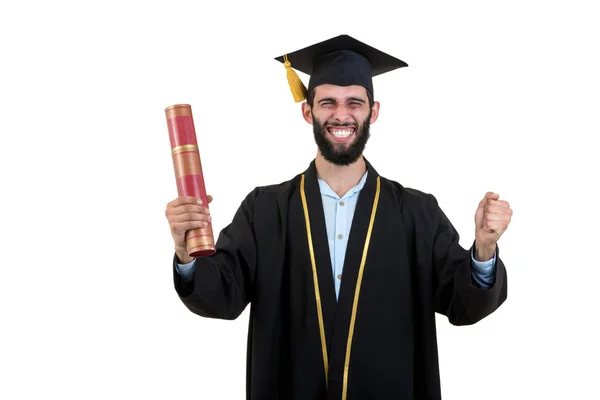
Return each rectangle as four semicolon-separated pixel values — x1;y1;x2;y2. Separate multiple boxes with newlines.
173;190;257;319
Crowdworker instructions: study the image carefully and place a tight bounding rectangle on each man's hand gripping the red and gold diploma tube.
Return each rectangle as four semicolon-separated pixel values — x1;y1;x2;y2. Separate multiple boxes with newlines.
165;195;213;264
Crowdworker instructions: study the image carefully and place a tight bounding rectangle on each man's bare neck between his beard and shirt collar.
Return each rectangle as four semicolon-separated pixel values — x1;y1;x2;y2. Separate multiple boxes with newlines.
315;153;367;197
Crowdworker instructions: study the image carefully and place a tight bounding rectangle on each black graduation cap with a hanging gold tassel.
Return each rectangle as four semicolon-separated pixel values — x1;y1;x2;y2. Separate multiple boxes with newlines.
275;35;408;102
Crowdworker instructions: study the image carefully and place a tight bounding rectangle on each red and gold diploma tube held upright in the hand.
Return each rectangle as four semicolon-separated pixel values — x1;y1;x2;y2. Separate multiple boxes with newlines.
165;104;216;257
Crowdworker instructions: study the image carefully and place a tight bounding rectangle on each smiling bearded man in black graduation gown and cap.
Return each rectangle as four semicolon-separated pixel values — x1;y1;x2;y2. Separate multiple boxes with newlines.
166;35;512;400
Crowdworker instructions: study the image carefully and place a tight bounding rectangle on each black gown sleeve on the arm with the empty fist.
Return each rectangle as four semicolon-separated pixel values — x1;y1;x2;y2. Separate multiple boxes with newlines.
429;195;507;325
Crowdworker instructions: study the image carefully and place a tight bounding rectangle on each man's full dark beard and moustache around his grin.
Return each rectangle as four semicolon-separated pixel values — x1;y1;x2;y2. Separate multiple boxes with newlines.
312;112;371;166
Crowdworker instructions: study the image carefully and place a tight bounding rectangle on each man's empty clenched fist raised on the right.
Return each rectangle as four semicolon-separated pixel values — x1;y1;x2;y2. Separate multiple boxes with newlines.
475;192;512;261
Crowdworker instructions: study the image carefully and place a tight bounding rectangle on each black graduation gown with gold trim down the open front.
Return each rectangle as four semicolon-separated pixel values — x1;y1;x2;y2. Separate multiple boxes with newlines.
173;161;507;400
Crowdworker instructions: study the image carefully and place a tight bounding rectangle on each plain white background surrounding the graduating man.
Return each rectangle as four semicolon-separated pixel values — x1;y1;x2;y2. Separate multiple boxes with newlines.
0;1;600;400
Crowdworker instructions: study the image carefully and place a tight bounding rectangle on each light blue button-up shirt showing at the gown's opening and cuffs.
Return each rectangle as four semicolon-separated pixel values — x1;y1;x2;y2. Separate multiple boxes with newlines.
177;172;496;298
